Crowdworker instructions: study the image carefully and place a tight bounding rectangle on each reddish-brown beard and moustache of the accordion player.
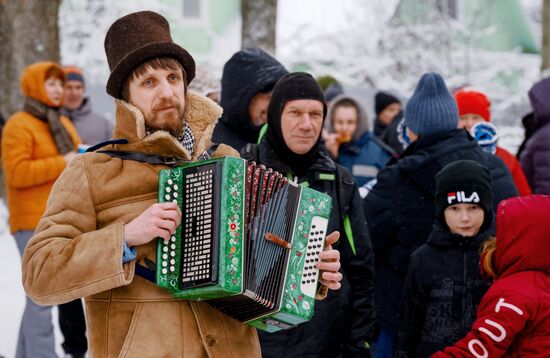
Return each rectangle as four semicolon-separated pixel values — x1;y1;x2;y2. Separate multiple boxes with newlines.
145;99;184;138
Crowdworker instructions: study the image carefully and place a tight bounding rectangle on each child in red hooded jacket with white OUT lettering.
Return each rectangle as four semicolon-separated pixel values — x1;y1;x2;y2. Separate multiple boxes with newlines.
432;195;550;358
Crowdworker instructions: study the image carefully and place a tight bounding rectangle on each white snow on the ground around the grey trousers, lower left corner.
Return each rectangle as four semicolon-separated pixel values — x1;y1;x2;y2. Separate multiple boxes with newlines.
0;200;63;358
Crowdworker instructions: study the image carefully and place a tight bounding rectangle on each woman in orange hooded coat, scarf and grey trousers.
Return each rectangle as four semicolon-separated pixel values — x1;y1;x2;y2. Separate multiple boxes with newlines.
2;62;80;358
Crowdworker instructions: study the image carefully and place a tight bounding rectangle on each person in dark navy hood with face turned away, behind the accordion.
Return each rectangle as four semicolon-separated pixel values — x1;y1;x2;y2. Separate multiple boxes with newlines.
212;48;287;151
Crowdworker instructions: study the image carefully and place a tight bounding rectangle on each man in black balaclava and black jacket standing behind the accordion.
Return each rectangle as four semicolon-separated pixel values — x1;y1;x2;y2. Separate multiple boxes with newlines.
241;73;374;358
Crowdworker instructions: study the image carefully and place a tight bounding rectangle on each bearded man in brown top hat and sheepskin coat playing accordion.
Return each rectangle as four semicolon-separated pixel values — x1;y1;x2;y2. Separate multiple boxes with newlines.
23;11;342;357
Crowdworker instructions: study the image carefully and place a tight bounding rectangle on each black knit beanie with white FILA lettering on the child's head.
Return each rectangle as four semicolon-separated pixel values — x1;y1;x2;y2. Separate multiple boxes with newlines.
435;160;493;232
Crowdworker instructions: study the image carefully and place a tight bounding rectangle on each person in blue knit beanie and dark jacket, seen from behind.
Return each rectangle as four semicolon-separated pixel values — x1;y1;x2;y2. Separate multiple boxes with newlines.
364;73;518;356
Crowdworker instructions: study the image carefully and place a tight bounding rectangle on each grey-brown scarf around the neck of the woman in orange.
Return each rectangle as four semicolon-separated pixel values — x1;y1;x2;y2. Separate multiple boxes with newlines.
23;97;75;155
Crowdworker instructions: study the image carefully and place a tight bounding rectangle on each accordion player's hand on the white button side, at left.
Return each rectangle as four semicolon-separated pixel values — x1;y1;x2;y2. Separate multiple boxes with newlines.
124;202;181;247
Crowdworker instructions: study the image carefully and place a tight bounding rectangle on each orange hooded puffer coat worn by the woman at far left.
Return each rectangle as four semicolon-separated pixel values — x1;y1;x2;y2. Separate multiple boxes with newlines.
2;62;80;233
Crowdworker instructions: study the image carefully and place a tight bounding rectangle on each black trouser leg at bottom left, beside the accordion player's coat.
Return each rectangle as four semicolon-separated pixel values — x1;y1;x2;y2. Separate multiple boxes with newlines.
58;299;88;356
